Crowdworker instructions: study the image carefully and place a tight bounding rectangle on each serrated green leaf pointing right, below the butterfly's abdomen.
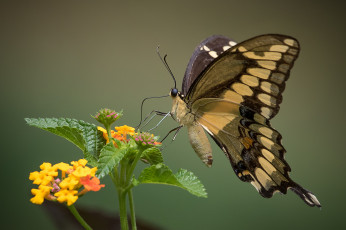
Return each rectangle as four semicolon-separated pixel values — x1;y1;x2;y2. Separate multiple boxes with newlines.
138;163;207;197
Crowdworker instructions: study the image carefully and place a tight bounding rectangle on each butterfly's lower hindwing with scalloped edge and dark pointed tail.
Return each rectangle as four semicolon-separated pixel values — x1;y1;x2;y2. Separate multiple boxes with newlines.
192;98;319;206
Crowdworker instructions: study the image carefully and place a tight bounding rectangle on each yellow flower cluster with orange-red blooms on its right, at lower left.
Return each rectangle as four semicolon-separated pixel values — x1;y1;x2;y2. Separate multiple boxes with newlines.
29;159;105;206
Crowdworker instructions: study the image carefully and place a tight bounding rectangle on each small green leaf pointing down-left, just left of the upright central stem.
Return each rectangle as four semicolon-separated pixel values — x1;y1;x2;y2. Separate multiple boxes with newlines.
96;142;127;178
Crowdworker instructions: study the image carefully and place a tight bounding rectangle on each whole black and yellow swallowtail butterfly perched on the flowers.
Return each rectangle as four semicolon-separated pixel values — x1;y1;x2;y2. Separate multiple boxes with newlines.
170;34;321;207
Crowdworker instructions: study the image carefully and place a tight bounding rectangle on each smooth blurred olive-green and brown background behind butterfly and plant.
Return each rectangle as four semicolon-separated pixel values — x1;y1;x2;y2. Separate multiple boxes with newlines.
0;0;346;229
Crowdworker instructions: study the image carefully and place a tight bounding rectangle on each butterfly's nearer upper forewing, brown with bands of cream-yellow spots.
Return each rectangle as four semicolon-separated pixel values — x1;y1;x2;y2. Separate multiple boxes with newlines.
185;35;299;119
